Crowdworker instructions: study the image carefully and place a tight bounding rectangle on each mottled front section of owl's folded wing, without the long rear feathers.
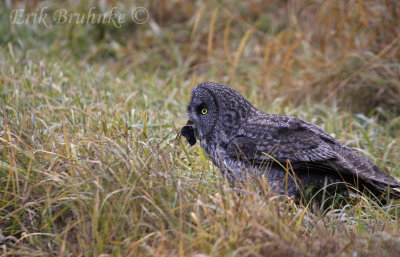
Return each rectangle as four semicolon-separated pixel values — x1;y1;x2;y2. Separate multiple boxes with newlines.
227;121;337;162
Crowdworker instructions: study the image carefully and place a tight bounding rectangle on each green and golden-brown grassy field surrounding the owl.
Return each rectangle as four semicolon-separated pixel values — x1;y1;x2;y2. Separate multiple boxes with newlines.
0;0;400;257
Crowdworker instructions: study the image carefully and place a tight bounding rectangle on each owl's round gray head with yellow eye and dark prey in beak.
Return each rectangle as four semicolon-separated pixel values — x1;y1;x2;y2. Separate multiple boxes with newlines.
181;82;253;145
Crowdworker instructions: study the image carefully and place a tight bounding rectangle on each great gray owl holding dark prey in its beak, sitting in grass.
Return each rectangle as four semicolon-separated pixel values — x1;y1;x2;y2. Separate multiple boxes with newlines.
181;82;400;198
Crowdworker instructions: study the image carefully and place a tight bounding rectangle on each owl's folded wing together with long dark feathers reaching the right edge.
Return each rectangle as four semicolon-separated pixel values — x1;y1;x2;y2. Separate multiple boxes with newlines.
227;122;399;195
